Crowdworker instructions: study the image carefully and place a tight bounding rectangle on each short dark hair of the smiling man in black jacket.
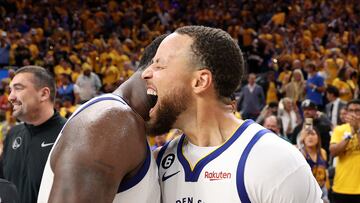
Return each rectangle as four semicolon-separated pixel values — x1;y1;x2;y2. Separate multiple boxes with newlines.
15;66;56;103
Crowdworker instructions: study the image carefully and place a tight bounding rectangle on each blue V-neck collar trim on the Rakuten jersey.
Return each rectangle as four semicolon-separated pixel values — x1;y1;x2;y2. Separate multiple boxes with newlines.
177;120;254;182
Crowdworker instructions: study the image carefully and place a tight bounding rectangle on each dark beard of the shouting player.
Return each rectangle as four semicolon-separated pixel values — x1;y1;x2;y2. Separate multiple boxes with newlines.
146;89;190;135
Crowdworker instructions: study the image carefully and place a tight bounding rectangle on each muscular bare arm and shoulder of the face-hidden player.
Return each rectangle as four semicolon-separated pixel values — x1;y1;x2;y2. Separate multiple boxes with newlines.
49;101;146;203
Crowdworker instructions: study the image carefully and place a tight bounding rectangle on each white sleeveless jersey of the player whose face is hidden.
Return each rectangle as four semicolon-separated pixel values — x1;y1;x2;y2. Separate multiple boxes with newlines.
38;94;160;203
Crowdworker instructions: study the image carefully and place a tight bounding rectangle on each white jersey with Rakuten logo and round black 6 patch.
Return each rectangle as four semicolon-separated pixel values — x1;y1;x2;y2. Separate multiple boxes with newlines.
157;120;321;203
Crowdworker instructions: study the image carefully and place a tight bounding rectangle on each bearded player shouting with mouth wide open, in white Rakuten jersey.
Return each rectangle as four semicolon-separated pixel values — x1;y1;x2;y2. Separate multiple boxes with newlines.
142;26;321;203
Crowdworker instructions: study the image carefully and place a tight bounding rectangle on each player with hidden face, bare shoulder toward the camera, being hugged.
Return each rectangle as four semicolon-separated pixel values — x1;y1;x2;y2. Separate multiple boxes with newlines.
38;36;164;203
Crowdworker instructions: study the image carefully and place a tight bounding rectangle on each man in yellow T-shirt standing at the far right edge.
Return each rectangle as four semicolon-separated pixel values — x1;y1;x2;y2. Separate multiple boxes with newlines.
330;99;360;203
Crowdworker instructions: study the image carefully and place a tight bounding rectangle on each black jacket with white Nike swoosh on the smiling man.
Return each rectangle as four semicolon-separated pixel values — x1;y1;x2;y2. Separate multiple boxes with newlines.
3;112;66;203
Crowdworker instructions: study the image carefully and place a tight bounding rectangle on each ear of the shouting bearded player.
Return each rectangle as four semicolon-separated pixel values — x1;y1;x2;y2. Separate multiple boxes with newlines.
192;69;213;93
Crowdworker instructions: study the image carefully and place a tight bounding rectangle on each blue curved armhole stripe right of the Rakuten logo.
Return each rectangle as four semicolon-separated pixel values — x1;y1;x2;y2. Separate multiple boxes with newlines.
236;129;271;203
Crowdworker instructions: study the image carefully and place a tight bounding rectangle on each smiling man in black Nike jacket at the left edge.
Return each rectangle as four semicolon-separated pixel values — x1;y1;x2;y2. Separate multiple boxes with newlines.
2;66;66;203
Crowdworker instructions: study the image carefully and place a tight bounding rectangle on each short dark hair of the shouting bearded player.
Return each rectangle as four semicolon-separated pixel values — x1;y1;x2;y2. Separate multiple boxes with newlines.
175;26;244;97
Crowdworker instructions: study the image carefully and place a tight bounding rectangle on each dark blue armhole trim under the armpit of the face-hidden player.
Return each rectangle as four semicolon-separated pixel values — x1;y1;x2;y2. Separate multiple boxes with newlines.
118;144;152;193
